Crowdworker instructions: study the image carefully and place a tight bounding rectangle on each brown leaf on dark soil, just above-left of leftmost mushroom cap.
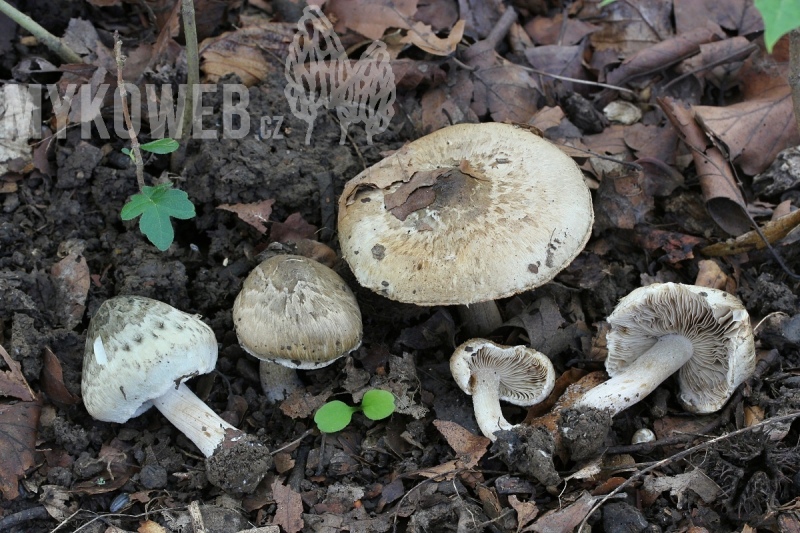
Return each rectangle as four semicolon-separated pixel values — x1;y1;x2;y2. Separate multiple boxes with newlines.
50;252;90;329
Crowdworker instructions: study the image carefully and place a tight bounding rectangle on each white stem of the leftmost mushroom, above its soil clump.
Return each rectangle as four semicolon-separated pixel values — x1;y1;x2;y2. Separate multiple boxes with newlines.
152;383;244;457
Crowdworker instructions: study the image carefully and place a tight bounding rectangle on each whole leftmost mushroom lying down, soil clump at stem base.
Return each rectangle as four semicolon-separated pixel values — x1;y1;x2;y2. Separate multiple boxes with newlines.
81;296;272;492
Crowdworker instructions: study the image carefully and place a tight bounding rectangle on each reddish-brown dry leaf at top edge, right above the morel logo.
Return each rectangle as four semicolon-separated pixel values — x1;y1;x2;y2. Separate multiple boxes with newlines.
325;0;418;40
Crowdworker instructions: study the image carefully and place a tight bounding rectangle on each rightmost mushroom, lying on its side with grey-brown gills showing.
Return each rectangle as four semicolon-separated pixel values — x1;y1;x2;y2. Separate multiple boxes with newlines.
577;283;755;416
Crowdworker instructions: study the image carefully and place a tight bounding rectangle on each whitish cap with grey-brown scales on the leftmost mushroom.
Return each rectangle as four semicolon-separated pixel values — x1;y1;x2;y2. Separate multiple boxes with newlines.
81;296;217;423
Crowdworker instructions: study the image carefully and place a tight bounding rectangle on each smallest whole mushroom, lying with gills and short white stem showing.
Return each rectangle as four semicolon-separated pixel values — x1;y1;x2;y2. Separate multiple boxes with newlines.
450;339;556;441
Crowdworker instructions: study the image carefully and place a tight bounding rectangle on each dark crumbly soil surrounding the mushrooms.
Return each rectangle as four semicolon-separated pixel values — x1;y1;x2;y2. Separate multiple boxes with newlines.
0;2;800;533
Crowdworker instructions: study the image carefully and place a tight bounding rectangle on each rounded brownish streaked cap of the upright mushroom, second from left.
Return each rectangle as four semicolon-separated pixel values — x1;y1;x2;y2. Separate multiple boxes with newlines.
233;255;362;369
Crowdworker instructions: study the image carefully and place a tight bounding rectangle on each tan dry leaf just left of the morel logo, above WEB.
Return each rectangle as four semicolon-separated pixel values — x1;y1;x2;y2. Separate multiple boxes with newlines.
200;22;296;87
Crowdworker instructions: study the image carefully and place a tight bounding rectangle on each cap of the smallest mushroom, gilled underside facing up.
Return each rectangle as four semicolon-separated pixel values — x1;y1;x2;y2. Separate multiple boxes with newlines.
450;339;556;407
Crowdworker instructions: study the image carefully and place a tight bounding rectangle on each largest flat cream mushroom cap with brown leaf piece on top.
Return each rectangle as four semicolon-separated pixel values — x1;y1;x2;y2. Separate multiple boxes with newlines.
338;123;594;305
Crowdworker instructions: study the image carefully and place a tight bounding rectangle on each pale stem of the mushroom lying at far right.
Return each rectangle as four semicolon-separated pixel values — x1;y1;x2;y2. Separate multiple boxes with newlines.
575;334;694;416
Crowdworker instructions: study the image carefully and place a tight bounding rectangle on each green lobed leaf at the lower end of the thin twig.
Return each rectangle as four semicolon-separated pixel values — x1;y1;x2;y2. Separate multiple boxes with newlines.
120;183;195;252
